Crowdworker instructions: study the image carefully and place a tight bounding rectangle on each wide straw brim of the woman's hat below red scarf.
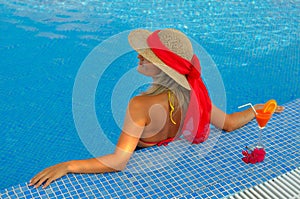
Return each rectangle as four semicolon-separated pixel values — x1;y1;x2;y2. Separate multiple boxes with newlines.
128;29;191;90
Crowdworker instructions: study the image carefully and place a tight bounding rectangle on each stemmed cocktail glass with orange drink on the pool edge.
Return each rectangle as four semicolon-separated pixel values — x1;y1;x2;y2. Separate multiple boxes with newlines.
249;106;272;150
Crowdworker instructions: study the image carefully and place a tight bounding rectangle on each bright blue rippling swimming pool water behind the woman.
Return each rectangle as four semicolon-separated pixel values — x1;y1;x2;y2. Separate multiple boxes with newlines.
0;0;300;189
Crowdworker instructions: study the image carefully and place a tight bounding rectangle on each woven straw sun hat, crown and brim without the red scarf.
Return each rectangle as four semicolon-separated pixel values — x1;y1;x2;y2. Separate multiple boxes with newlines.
128;29;194;90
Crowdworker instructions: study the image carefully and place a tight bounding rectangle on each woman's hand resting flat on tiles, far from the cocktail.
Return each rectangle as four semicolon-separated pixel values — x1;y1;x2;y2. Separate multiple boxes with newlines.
29;162;69;188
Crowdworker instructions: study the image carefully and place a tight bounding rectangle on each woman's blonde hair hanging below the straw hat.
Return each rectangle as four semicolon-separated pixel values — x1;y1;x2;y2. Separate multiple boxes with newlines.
141;71;190;124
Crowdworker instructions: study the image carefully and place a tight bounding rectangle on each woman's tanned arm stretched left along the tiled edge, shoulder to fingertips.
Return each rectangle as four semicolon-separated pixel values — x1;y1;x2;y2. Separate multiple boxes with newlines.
30;98;146;188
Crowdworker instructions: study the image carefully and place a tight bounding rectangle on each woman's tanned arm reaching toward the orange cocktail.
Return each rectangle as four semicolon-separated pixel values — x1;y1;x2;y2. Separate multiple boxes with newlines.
211;104;284;132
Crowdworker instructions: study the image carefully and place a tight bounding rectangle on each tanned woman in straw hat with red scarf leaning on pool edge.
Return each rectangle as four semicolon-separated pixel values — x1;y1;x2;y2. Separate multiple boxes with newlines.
30;29;283;187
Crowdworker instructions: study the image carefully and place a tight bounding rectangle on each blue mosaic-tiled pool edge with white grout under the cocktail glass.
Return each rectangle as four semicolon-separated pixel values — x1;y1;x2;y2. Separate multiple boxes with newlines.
0;99;300;199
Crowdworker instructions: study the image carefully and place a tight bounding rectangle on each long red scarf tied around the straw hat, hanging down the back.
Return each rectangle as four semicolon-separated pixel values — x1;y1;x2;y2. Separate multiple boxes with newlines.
147;30;211;144
